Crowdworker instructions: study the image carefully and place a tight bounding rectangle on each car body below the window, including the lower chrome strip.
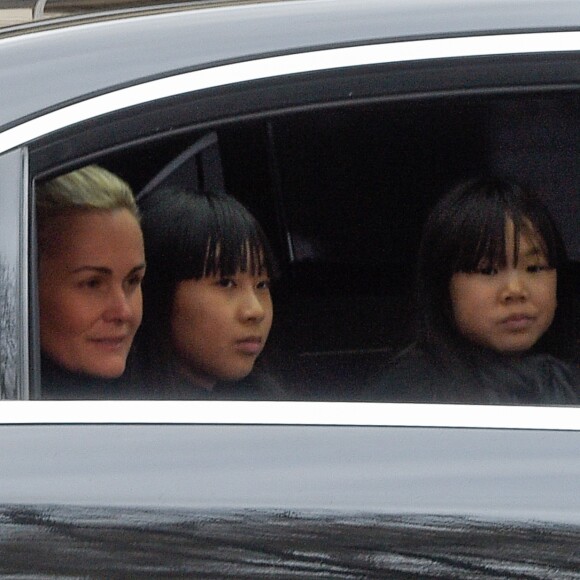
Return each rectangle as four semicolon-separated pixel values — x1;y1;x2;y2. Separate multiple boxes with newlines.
0;401;580;578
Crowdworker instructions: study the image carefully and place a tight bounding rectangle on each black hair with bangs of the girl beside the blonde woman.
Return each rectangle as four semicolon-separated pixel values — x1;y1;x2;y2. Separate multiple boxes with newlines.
136;188;275;382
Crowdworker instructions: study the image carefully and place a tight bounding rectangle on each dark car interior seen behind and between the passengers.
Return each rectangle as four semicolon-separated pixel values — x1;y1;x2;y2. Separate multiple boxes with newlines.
31;90;580;400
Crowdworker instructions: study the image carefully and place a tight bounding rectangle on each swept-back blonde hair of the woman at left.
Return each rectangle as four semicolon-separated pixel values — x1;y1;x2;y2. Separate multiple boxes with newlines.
36;165;139;252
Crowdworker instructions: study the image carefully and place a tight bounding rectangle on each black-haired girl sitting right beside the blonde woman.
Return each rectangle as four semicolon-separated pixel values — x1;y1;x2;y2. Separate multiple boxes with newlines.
131;189;280;399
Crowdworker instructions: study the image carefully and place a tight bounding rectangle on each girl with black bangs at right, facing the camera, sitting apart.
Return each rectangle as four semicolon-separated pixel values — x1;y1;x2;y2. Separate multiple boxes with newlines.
372;179;580;405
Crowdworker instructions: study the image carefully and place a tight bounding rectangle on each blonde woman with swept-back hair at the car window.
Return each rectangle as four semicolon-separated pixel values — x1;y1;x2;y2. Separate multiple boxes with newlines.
36;165;145;399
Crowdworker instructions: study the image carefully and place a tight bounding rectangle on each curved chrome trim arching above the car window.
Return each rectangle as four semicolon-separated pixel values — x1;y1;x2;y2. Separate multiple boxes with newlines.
0;31;580;153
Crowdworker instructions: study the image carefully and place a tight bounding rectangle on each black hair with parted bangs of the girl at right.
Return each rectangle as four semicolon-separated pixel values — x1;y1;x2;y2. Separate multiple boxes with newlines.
416;178;572;358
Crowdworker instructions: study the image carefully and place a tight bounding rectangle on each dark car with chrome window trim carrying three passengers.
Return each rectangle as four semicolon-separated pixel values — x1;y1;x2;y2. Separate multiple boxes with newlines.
0;0;580;578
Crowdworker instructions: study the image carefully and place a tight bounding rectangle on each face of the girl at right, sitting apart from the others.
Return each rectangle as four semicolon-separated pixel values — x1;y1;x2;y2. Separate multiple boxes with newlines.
449;221;557;354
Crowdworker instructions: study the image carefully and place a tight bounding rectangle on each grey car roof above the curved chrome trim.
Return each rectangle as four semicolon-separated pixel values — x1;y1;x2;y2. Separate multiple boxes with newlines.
0;0;580;128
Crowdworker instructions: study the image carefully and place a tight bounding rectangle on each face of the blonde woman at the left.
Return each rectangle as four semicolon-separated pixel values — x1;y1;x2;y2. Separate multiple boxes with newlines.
39;209;145;378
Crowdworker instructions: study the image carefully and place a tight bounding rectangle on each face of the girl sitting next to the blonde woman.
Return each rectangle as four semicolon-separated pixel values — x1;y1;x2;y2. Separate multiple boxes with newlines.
171;271;273;389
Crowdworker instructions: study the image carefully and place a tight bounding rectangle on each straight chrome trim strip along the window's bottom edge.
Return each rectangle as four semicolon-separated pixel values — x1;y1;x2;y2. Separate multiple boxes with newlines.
0;401;580;431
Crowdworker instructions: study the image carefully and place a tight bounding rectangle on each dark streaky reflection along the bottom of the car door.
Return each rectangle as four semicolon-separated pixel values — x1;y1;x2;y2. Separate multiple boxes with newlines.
0;506;580;578
